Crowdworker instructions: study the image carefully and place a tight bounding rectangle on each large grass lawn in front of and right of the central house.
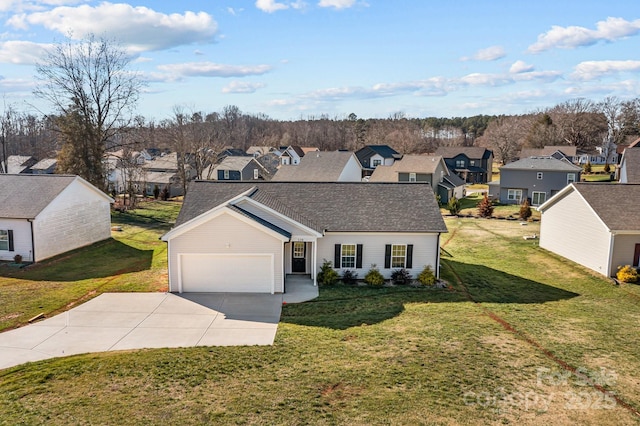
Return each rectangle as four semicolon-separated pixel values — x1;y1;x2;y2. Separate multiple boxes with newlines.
0;218;640;425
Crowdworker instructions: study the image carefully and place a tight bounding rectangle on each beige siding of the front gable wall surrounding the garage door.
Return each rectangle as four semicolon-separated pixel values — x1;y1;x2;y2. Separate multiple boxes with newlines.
169;213;283;293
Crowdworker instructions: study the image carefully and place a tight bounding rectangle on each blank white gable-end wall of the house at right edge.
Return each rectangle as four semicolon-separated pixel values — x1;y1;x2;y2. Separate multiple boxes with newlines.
540;191;612;276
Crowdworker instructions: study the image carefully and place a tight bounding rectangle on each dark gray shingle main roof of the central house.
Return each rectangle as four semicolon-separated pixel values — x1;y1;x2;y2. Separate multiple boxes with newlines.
176;181;447;232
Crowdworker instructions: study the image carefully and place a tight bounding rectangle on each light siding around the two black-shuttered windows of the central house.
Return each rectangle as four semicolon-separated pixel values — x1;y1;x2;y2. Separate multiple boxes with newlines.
317;232;439;279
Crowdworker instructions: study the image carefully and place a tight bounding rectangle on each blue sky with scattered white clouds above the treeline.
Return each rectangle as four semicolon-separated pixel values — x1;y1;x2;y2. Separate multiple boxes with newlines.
0;0;640;120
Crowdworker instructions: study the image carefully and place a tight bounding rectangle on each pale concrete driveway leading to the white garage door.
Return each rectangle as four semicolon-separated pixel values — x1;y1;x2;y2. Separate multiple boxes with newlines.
0;290;282;369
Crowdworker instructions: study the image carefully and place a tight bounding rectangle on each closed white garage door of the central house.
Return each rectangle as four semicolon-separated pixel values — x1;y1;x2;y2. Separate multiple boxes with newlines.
180;254;274;293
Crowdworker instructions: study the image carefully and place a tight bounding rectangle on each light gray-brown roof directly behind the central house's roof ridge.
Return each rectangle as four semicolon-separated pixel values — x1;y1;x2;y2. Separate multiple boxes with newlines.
272;151;360;182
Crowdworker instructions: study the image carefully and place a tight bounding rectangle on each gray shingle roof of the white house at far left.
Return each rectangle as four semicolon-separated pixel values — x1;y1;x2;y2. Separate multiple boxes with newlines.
0;174;76;219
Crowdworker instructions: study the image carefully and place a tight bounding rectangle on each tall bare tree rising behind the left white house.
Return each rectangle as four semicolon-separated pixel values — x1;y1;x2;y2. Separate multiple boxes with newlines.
34;35;143;188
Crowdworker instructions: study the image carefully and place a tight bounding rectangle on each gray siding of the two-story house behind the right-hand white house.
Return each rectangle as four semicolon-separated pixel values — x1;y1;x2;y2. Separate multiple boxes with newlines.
500;169;579;204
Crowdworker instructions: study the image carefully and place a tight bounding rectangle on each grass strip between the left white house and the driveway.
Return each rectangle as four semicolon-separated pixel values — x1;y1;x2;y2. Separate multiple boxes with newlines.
0;202;180;330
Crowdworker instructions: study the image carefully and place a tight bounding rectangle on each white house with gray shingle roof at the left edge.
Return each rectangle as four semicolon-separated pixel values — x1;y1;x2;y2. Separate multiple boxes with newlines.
0;174;113;262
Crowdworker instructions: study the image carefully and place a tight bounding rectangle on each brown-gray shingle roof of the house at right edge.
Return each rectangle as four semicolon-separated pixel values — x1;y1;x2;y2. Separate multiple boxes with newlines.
573;182;640;231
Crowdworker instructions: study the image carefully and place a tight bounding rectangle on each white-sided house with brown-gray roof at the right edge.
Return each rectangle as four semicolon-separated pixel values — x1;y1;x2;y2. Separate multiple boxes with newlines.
538;183;640;277
